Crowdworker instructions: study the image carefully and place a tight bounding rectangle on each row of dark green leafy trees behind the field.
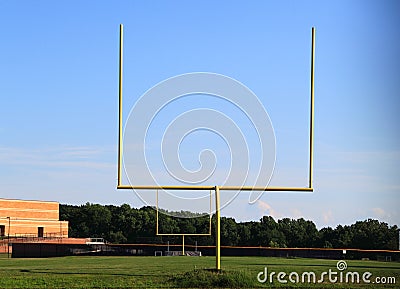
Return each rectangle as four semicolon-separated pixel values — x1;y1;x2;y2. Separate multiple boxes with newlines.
60;203;399;250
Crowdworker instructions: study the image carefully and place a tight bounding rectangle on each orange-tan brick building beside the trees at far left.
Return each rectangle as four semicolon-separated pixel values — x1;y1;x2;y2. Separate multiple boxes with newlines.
0;198;68;238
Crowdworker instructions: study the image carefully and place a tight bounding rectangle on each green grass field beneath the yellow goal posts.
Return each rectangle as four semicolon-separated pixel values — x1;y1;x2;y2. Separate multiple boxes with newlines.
0;255;400;288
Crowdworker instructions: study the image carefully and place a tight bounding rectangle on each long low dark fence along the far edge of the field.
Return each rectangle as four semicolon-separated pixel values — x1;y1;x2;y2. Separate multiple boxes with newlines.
12;242;400;261
